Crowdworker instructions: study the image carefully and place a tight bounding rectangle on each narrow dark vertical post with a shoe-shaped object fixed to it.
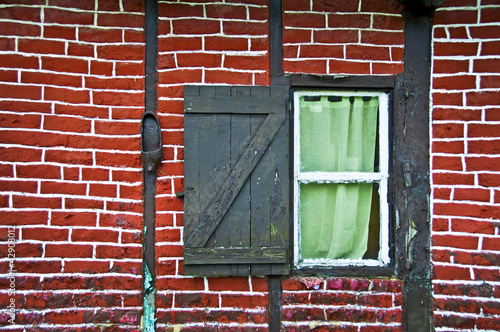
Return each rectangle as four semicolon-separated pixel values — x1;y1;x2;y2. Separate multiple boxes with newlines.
141;0;159;332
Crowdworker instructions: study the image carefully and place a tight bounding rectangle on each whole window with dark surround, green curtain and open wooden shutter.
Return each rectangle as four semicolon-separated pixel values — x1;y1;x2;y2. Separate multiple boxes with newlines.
183;76;397;276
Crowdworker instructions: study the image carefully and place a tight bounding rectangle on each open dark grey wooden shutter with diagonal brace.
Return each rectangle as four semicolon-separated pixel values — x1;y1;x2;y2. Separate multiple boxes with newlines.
184;86;290;276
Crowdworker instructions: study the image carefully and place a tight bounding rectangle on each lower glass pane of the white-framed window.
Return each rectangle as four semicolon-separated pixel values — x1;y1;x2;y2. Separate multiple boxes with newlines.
299;183;380;259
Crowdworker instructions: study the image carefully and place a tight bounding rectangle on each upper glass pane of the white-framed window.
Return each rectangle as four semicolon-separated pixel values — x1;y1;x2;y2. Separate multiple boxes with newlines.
300;96;379;172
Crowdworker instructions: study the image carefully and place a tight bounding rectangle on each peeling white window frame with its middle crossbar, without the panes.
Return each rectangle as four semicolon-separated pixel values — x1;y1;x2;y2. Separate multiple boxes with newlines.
293;90;390;269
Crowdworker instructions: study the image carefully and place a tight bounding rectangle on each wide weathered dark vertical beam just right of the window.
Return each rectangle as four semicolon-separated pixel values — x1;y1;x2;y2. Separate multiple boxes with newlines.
392;9;432;332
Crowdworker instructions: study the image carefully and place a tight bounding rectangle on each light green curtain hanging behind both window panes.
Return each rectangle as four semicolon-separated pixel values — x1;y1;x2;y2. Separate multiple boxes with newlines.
299;96;378;259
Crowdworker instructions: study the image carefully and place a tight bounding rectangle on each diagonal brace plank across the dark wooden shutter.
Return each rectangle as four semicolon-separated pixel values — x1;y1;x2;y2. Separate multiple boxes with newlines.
186;114;285;247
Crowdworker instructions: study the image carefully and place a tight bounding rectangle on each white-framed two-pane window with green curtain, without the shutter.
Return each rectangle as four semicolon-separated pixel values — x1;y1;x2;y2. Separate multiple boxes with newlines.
293;91;390;268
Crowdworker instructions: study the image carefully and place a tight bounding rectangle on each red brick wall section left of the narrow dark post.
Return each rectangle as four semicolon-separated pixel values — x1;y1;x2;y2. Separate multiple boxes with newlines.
0;0;144;331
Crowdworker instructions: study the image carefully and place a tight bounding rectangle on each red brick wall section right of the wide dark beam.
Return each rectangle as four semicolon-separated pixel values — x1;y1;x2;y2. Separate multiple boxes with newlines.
431;0;500;330
